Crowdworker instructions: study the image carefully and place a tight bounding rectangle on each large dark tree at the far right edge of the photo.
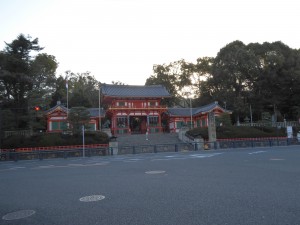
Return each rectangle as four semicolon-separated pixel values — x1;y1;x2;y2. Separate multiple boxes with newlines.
249;42;300;119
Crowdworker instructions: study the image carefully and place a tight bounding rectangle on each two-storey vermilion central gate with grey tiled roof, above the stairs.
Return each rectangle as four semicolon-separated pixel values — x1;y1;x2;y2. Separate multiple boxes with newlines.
101;84;171;134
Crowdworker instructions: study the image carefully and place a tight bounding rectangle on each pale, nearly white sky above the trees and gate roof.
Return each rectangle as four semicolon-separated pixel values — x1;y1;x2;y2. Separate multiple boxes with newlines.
0;0;300;85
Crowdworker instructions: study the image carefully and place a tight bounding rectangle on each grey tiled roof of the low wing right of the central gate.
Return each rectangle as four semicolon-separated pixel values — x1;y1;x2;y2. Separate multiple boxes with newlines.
168;102;231;116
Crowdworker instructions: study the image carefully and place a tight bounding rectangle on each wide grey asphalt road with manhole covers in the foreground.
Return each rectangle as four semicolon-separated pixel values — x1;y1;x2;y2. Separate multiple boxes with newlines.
0;146;300;225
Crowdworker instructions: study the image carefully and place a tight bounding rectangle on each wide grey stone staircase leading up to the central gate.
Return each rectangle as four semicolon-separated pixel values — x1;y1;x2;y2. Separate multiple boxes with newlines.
117;133;181;147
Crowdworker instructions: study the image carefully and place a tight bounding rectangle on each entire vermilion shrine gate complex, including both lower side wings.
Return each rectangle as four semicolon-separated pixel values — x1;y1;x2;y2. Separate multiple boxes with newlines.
46;84;231;135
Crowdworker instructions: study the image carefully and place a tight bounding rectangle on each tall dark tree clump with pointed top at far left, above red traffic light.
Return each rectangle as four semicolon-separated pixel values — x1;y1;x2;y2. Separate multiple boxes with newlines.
0;34;57;131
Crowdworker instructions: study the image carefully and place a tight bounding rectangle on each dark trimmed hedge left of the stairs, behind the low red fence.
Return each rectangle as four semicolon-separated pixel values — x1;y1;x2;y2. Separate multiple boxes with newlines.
1;132;109;149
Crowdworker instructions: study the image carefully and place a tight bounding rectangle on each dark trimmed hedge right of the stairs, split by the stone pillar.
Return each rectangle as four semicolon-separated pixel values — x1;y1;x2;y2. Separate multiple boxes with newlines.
187;126;287;139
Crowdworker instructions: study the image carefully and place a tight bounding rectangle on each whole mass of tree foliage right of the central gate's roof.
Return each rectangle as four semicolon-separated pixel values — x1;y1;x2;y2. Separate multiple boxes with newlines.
146;41;300;123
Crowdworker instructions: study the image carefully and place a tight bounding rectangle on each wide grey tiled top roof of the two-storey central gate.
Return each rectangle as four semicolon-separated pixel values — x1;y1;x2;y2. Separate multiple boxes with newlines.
101;84;171;98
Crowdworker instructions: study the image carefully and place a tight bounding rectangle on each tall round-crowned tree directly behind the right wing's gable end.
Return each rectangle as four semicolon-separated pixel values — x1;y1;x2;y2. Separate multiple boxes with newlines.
207;41;259;122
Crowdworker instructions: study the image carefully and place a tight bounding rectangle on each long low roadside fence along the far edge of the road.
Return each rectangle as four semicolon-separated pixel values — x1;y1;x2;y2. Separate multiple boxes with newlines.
0;137;300;161
